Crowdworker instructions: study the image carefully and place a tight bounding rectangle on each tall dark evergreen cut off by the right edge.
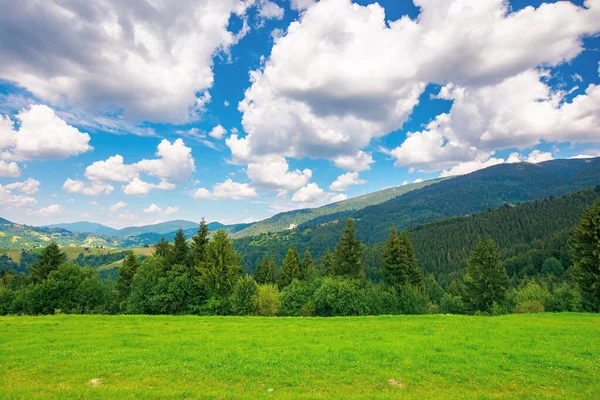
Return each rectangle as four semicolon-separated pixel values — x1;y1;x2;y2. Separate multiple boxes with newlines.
571;200;600;312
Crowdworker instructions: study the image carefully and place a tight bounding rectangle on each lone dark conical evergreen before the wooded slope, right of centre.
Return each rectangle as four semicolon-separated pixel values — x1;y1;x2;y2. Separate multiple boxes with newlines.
465;237;508;312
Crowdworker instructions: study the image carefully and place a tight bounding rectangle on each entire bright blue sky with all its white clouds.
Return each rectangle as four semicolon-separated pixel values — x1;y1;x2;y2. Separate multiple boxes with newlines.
0;0;600;227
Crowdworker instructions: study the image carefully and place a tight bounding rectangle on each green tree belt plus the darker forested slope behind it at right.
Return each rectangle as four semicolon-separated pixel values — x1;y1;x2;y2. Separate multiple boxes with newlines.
0;191;600;316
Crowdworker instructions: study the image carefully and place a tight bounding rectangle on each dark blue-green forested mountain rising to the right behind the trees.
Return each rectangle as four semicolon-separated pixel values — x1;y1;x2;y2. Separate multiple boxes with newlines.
234;158;600;268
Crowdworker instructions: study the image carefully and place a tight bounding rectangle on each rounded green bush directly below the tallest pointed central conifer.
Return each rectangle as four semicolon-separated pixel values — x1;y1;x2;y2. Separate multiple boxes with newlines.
314;278;369;317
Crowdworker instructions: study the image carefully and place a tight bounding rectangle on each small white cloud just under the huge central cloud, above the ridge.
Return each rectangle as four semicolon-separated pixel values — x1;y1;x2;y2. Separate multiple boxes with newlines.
246;157;312;190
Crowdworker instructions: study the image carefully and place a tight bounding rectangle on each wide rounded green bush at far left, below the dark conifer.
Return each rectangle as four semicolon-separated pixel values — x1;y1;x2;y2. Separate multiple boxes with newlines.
25;263;114;314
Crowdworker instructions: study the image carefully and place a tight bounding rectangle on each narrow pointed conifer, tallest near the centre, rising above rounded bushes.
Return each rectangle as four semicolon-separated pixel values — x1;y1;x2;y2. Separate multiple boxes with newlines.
333;218;364;278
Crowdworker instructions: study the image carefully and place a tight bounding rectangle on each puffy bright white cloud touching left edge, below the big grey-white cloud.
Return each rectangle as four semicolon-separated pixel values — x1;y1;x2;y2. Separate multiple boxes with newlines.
0;104;93;161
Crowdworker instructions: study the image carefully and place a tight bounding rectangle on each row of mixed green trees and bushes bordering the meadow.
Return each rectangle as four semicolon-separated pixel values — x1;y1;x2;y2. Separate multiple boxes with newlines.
0;197;600;316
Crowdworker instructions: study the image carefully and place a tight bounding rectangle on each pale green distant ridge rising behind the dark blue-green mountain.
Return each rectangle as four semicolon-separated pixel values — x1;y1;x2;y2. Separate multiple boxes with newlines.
233;178;448;238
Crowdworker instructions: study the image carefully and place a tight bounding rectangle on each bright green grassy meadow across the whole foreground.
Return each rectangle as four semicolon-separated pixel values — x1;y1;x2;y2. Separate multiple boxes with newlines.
0;314;600;399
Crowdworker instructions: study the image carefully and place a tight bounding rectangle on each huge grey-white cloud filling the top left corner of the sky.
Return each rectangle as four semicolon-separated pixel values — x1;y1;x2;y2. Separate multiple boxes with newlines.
0;0;252;123
